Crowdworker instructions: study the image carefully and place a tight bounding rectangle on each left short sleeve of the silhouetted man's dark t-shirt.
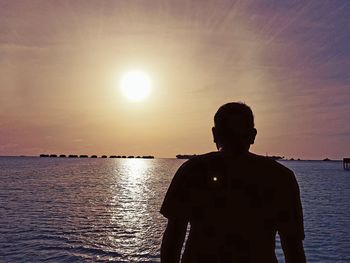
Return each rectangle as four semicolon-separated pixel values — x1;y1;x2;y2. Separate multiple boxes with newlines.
160;161;191;221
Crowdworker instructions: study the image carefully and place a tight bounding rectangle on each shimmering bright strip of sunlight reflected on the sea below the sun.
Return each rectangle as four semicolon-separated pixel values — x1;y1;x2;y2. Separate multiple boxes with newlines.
109;159;153;255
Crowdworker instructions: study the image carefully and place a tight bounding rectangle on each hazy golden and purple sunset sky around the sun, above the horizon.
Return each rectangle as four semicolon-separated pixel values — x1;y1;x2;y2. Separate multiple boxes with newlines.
0;0;350;159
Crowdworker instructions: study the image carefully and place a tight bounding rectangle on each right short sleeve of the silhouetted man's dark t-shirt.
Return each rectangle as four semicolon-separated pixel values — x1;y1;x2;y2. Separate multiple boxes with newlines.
277;172;305;240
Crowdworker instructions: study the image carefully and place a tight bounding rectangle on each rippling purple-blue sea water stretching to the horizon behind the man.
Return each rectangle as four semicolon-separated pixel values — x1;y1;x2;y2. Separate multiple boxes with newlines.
0;157;350;263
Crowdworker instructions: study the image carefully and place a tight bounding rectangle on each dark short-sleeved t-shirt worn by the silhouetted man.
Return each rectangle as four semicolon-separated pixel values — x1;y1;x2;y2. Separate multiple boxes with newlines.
160;152;304;263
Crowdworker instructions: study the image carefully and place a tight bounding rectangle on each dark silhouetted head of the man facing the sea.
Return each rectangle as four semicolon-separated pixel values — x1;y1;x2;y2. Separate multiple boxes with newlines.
213;102;257;153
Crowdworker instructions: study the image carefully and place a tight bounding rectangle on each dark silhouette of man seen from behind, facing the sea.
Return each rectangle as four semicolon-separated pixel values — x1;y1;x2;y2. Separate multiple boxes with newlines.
160;103;306;263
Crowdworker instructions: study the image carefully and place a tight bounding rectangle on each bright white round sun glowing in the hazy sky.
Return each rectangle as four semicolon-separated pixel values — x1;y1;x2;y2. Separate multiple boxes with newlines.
120;70;151;101
